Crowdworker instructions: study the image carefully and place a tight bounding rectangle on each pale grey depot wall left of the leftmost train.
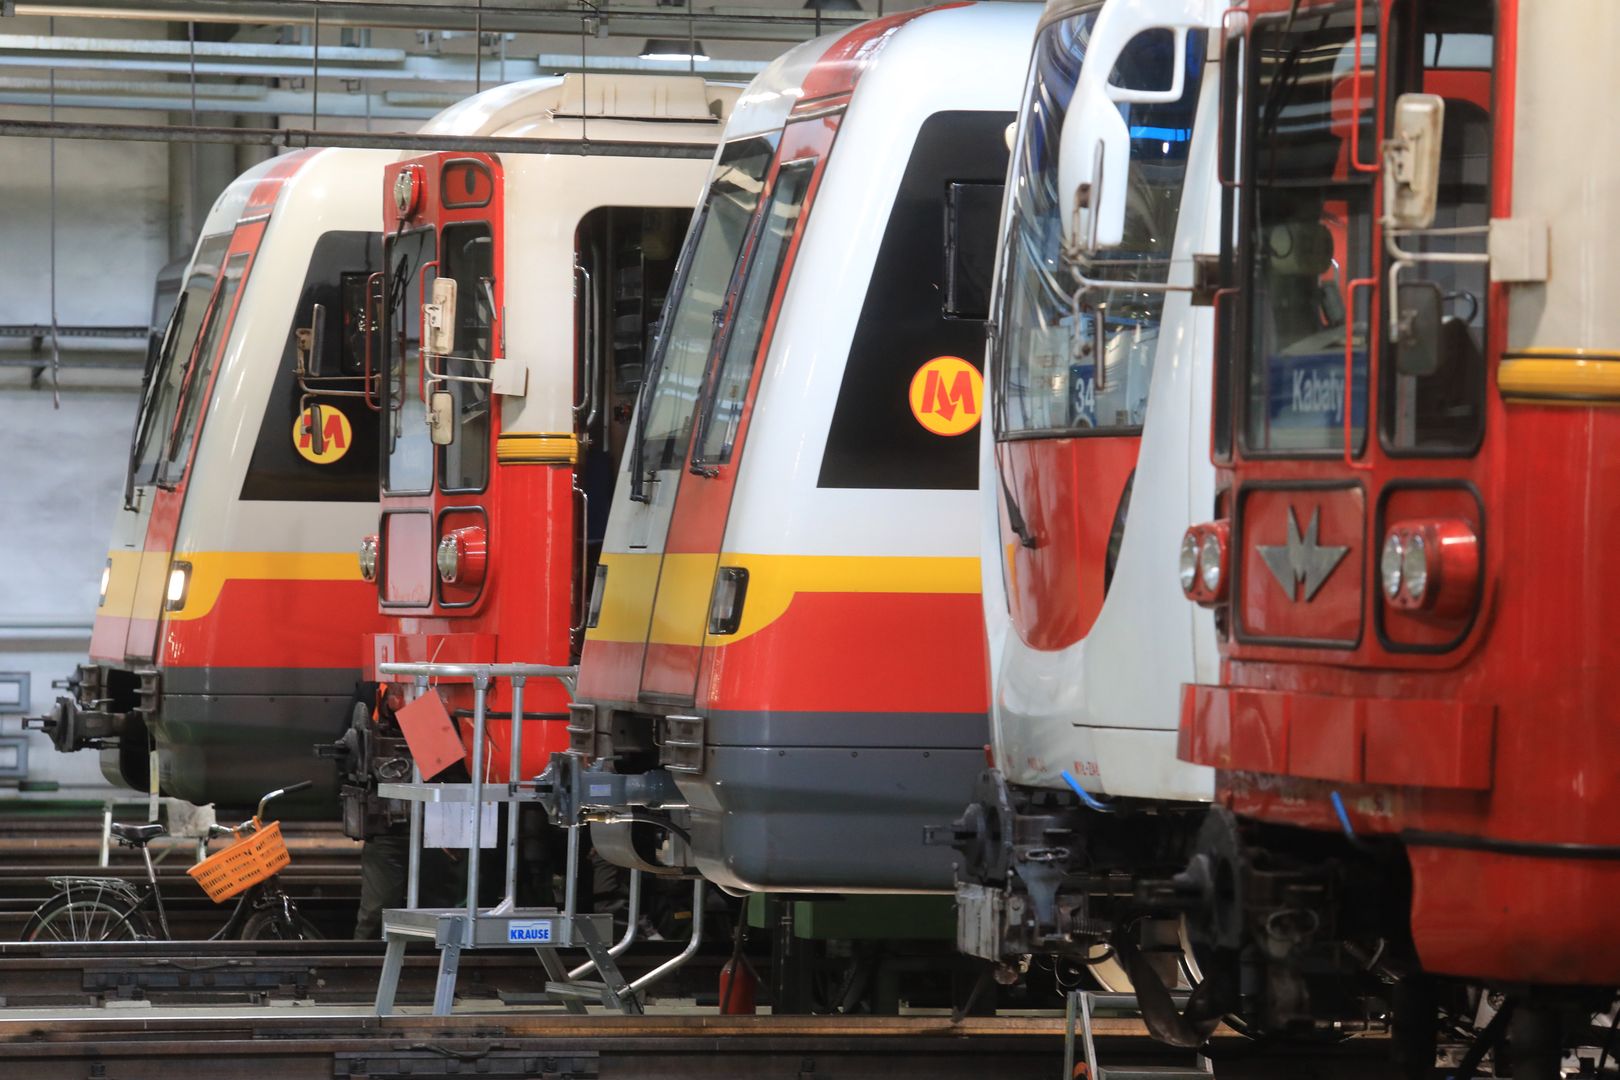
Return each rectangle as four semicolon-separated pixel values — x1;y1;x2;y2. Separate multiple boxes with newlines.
0;18;194;797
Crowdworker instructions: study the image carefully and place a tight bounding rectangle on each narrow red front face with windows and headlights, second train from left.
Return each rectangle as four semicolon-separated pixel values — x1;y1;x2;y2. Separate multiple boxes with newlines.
376;154;504;634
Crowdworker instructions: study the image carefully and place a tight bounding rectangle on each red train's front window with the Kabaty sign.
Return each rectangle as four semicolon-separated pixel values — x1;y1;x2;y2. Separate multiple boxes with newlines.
1238;8;1377;455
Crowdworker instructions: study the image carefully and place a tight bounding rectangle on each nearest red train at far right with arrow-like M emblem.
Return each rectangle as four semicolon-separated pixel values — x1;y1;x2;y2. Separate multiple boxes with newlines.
1144;0;1620;1078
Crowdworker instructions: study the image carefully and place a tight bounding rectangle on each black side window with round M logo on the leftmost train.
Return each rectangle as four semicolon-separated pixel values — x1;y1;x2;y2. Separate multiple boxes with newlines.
241;232;382;502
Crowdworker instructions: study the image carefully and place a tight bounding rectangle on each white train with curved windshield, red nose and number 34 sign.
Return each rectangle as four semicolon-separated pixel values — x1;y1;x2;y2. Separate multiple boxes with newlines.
930;0;1220;1003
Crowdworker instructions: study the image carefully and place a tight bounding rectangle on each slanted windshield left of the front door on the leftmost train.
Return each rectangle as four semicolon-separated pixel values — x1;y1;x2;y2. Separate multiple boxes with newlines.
130;232;241;486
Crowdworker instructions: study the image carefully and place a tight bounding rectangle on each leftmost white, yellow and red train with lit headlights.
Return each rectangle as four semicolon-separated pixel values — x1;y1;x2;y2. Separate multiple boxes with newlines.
44;149;389;816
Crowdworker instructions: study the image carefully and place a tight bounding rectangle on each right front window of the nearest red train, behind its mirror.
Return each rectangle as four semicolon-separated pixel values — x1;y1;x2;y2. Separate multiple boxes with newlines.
1379;0;1494;453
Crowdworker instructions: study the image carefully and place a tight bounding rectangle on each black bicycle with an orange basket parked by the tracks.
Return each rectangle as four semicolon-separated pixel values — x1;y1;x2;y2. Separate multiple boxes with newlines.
23;780;321;941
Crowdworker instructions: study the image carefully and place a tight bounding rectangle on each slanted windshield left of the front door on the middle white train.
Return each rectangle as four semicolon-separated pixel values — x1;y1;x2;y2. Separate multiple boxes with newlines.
637;136;776;476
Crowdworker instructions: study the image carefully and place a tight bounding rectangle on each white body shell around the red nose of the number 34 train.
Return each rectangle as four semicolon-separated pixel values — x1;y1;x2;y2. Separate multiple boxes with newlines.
980;0;1220;800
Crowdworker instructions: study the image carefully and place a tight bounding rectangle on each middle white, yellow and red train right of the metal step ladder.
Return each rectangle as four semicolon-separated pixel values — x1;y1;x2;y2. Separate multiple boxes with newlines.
559;5;1038;894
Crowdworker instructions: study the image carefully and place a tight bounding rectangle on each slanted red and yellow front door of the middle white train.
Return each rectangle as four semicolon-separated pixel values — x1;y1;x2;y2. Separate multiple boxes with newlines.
640;122;839;704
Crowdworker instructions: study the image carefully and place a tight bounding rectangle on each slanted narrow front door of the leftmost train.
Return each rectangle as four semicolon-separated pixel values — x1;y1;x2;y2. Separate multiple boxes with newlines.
123;190;273;661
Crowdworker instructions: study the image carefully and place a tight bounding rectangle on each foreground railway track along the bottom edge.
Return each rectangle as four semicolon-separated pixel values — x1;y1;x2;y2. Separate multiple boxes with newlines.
0;1014;1387;1080
